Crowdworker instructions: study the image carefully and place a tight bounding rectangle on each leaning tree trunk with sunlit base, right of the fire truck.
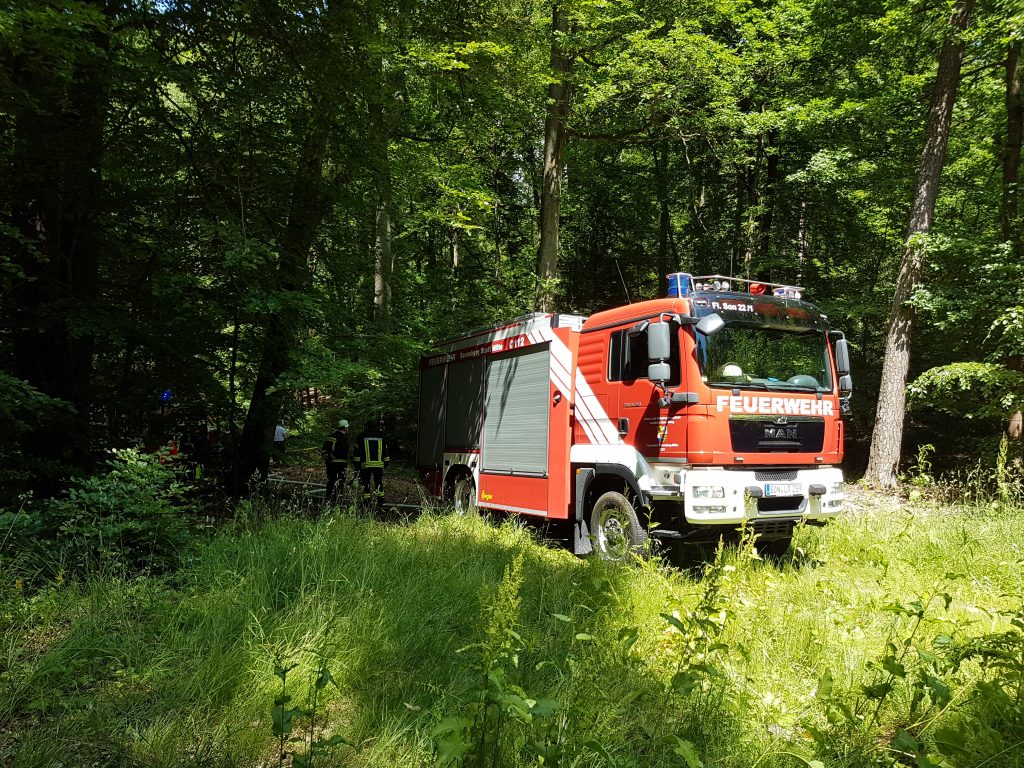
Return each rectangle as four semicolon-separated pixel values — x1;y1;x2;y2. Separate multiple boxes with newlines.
865;0;974;487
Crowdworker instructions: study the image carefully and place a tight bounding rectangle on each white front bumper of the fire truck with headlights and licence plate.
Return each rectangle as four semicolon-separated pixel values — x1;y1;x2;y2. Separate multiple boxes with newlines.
680;467;846;525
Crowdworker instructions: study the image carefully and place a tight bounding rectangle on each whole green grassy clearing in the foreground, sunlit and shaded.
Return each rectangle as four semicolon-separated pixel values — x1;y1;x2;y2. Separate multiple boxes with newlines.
0;493;1024;767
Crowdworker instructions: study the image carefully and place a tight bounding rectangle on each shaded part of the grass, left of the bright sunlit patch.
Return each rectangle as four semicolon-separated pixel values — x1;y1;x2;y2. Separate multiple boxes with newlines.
0;505;761;766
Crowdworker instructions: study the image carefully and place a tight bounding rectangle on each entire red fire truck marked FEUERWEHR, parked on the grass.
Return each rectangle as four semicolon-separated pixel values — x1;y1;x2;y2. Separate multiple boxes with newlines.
417;272;853;558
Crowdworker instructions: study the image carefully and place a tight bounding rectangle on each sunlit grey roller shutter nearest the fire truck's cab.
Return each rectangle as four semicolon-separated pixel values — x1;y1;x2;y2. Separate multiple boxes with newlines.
481;345;550;475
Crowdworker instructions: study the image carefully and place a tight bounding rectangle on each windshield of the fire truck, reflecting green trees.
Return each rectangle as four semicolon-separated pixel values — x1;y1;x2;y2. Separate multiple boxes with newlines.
696;324;833;392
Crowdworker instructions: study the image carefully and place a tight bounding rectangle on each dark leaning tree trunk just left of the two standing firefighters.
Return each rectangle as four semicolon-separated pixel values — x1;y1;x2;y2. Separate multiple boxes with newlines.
234;125;327;493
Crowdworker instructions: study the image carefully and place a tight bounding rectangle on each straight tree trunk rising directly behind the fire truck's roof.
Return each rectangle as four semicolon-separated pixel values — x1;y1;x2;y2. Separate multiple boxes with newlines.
537;2;572;312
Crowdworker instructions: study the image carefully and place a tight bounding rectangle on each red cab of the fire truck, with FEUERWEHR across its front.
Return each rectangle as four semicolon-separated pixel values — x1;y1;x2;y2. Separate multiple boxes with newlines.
572;273;852;561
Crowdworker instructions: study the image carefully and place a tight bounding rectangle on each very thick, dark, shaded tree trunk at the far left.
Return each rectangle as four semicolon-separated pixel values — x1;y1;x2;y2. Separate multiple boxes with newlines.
4;0;112;492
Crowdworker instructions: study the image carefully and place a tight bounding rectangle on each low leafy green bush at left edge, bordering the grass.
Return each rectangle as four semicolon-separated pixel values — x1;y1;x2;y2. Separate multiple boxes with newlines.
0;449;189;571
